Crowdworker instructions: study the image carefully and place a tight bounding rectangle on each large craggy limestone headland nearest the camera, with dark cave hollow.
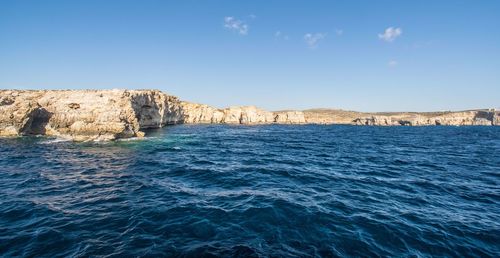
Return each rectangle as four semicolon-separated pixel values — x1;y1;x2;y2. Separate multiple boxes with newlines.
0;90;183;141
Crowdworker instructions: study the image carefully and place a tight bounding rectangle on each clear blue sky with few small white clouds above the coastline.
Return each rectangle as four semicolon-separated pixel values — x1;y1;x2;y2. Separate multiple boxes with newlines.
0;0;500;111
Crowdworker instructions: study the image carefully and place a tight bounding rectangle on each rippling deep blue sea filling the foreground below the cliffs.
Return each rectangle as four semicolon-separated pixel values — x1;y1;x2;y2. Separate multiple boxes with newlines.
0;125;500;257
